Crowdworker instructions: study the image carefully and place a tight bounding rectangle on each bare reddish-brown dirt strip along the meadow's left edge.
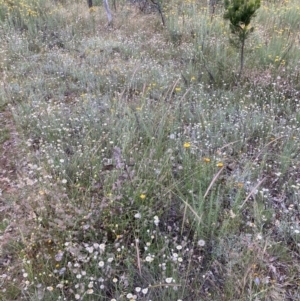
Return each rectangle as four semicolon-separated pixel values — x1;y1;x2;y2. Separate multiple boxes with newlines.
0;110;23;301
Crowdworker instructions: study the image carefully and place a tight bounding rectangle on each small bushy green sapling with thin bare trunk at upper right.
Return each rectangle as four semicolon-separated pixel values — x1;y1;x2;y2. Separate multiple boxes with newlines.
224;0;260;80
